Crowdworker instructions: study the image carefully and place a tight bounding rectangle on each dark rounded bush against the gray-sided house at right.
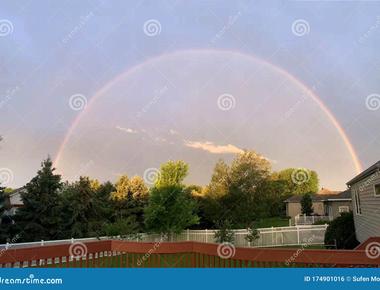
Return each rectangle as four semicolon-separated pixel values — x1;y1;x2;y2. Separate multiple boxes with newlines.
325;212;359;249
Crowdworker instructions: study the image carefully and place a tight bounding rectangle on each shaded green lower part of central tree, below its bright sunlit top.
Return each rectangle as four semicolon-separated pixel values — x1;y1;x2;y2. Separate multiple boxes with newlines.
145;185;199;235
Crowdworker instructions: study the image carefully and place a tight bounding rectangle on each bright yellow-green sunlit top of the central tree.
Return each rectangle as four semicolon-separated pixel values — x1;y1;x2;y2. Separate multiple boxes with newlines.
155;160;189;187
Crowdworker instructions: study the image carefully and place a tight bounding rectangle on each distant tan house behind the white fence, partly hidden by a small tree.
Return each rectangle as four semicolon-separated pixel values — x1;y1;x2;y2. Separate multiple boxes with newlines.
285;188;352;220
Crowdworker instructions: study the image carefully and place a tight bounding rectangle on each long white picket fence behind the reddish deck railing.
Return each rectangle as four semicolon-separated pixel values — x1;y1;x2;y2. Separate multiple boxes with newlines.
0;225;327;249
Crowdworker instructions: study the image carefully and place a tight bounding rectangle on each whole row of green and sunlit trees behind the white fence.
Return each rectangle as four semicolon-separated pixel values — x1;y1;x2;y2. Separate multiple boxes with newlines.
0;151;319;242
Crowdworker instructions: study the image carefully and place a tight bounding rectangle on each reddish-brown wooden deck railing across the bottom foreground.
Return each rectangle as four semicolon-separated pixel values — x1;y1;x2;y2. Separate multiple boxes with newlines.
0;240;380;268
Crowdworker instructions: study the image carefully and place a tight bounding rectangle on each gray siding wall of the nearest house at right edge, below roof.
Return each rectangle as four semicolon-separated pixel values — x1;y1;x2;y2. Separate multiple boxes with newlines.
351;172;380;243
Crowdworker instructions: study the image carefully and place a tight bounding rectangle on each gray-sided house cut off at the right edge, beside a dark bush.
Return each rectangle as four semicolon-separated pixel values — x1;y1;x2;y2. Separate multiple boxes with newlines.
347;161;380;243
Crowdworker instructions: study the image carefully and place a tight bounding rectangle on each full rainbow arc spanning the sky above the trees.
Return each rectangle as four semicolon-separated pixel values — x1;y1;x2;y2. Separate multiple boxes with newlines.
54;49;362;173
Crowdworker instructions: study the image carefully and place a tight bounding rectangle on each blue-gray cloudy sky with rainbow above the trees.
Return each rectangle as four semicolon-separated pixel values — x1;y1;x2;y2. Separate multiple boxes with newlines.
0;0;380;190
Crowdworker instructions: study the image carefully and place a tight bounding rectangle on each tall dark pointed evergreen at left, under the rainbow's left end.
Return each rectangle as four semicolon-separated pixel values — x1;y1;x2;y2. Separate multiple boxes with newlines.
15;157;62;241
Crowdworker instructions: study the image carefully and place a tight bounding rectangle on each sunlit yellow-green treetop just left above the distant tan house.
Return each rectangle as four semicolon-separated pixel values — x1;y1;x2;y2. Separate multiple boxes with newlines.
276;168;319;195
